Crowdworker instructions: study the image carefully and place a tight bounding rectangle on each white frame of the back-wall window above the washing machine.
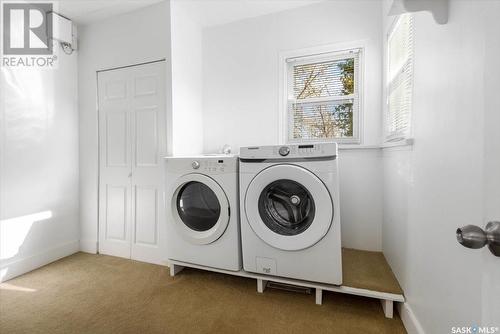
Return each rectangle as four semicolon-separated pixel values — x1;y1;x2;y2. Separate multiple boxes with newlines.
278;41;365;144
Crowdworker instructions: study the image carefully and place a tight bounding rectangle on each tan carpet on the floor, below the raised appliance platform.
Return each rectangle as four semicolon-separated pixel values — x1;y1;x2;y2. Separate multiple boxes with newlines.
0;253;405;334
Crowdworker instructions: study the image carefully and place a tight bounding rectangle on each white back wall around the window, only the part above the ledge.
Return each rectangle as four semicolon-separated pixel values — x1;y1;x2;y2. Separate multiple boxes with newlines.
203;1;382;151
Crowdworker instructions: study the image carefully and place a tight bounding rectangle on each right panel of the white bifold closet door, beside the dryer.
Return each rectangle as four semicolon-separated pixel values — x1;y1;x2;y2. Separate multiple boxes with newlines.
130;62;167;264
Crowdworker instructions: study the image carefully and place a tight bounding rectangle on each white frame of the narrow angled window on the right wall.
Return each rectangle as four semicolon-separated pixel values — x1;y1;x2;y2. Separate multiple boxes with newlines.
383;13;415;146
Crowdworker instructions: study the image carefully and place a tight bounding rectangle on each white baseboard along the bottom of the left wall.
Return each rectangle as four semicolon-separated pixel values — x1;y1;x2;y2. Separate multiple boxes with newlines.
0;240;80;282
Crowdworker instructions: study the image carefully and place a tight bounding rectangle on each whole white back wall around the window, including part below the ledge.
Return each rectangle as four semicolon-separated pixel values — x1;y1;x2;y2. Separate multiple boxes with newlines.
203;1;382;250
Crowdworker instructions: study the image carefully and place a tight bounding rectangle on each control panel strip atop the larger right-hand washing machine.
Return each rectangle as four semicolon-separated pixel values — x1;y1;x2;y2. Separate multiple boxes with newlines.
240;143;338;160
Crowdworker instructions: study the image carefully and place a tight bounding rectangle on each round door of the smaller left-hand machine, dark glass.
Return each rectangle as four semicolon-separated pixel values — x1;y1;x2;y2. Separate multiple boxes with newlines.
171;174;229;245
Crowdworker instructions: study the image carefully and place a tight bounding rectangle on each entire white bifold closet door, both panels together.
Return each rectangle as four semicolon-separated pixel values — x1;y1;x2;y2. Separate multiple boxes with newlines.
98;62;166;264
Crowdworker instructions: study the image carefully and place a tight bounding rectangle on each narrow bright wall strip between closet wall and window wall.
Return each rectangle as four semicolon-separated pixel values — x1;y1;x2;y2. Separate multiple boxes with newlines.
170;1;203;155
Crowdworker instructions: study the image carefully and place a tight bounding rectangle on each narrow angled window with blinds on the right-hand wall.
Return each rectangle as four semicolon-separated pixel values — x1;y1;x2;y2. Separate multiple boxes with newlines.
385;14;413;141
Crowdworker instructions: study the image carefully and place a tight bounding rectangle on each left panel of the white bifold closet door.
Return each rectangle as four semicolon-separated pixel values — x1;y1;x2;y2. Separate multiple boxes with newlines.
98;66;132;258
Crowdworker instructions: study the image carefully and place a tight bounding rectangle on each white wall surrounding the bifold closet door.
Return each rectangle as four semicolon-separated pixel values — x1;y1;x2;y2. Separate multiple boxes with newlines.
78;2;172;252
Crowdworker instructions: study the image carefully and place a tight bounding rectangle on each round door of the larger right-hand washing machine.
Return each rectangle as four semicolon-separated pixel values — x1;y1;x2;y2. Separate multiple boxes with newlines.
245;165;333;250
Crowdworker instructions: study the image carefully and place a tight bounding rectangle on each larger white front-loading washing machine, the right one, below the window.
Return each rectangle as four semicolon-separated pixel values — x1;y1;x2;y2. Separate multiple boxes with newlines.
240;144;342;285
